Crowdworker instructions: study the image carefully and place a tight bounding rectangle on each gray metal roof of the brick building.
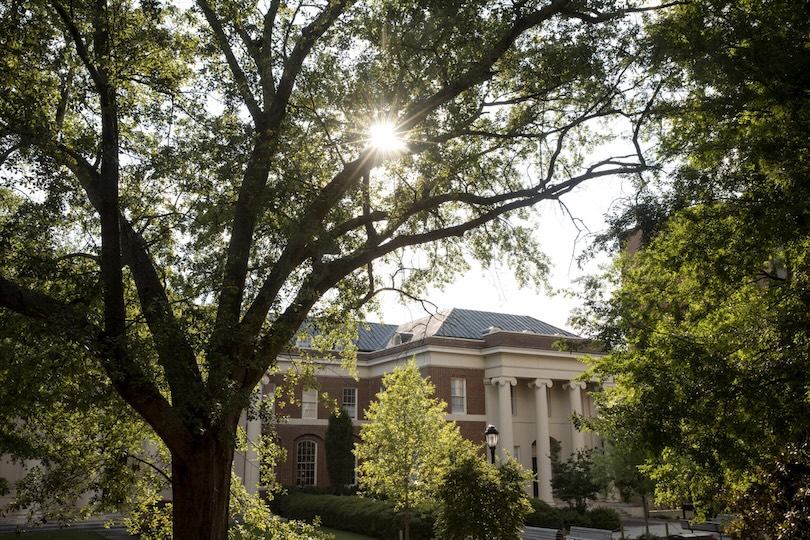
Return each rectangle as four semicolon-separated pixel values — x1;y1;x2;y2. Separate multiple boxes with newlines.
357;308;578;351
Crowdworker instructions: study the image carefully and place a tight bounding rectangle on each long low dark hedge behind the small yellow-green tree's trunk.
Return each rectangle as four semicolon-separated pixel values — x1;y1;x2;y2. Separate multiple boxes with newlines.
270;492;435;540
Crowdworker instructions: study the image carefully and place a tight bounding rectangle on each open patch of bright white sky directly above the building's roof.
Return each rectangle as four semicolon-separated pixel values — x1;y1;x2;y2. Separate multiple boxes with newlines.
370;175;630;330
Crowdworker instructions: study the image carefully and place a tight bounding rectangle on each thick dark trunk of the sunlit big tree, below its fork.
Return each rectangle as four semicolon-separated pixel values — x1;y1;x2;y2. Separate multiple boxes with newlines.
172;434;233;540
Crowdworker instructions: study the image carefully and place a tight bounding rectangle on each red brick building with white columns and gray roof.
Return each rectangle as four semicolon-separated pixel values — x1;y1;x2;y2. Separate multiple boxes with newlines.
243;309;599;502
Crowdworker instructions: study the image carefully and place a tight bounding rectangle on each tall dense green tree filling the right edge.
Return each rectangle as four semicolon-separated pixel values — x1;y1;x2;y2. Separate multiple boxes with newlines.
582;0;810;538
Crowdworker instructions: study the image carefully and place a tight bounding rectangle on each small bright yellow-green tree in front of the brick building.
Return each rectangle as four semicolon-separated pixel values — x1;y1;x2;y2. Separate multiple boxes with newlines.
355;360;463;540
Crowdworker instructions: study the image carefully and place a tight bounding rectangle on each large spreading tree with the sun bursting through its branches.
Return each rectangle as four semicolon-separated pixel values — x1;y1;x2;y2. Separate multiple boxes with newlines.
0;0;652;540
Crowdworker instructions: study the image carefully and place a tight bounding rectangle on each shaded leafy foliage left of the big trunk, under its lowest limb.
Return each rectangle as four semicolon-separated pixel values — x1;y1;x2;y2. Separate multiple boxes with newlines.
0;312;168;523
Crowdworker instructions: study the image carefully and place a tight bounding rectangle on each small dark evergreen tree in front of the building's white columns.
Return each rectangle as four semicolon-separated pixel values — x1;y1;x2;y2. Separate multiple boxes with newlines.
551;443;599;513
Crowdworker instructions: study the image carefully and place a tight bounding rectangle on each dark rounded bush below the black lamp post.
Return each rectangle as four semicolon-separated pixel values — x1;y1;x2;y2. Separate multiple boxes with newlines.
436;444;532;540
